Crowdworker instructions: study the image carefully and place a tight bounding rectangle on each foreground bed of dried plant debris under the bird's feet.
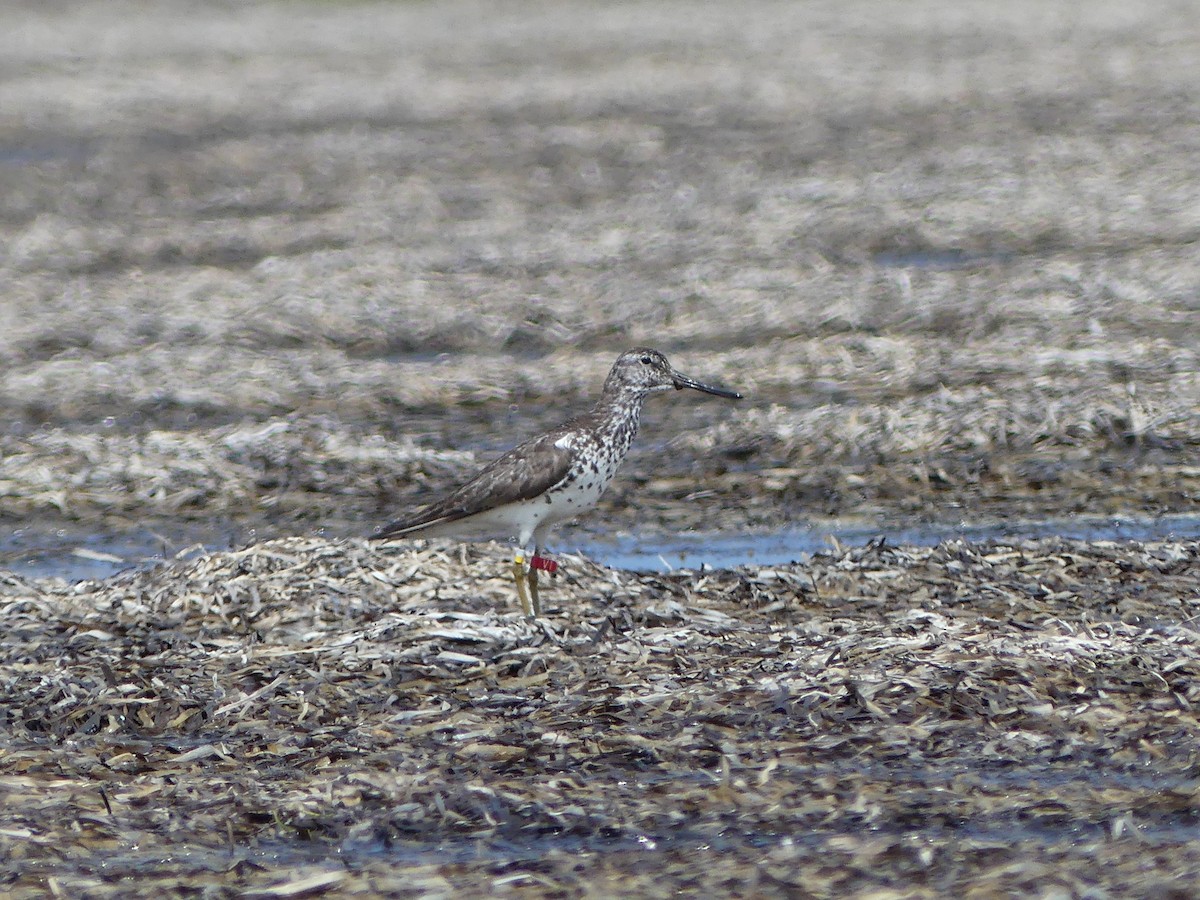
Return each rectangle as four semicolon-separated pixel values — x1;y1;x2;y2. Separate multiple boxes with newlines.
0;539;1200;896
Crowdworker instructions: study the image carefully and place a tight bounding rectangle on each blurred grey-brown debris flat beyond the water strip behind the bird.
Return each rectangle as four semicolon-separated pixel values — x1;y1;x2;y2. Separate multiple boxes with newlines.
0;2;1200;556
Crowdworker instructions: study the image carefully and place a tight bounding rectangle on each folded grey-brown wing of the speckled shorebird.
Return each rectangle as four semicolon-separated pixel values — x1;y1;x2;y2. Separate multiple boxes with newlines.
372;432;571;540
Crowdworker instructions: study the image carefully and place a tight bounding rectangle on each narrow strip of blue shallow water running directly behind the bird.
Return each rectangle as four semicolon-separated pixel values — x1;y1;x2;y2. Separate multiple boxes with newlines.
0;515;1200;581
